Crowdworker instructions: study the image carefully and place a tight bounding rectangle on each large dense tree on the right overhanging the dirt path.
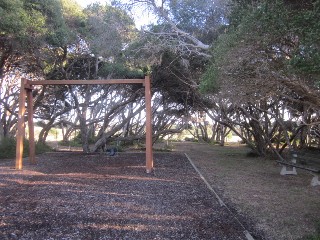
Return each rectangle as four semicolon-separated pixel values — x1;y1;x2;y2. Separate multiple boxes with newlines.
202;1;320;155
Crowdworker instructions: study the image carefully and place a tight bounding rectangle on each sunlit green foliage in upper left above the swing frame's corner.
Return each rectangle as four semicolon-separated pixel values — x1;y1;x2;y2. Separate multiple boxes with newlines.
0;0;77;82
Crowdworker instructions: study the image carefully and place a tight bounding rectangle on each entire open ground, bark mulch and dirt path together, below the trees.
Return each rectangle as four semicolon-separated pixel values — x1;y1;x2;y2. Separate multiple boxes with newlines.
0;142;320;240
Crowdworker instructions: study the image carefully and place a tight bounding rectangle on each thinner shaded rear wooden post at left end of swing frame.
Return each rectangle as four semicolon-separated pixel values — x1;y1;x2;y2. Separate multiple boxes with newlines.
27;86;36;164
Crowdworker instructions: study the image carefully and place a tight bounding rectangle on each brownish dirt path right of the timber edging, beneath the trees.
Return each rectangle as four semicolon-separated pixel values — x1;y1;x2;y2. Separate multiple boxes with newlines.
174;142;320;240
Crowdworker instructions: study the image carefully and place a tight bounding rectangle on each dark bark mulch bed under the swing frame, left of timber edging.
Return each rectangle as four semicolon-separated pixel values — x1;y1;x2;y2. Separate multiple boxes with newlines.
0;152;251;240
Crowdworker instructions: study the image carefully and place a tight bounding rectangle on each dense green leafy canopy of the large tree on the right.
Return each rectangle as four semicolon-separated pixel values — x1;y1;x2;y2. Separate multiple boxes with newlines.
202;0;320;92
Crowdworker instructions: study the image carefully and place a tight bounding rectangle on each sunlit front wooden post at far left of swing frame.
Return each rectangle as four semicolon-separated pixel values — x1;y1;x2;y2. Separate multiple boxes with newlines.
16;78;26;170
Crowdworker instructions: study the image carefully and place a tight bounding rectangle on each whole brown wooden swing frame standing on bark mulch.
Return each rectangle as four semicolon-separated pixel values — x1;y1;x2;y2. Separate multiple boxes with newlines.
15;76;153;173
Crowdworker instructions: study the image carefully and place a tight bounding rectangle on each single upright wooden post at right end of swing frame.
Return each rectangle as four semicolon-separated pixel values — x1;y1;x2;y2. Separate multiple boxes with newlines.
144;76;153;173
